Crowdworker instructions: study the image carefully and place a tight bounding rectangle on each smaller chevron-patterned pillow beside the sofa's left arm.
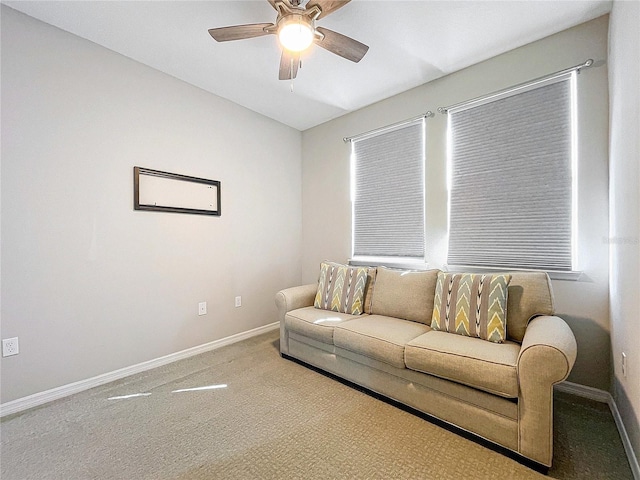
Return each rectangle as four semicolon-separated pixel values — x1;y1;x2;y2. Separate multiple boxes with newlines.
313;262;368;315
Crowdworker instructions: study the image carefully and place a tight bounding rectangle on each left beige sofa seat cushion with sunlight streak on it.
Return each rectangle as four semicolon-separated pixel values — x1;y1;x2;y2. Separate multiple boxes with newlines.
284;307;368;345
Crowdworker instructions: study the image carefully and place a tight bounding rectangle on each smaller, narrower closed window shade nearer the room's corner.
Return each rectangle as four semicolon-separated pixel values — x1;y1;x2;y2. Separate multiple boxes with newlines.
352;119;424;259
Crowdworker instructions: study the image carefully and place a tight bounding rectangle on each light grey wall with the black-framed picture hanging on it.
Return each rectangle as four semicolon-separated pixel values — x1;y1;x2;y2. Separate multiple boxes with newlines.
0;5;301;403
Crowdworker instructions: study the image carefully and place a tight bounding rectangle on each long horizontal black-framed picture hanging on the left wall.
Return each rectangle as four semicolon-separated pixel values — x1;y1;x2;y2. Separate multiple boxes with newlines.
133;167;221;217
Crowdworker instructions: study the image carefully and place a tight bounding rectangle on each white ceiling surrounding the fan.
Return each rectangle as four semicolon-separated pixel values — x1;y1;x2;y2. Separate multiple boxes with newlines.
2;0;611;130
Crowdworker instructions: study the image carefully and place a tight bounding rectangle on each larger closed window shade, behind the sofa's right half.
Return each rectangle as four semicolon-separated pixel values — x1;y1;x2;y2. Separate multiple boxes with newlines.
448;76;572;271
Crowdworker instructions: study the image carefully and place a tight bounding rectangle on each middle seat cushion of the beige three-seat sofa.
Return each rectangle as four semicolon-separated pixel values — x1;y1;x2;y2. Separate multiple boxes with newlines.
333;315;431;368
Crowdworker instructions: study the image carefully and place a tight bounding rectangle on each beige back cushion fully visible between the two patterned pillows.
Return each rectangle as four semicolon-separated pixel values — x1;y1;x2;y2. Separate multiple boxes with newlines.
371;267;439;325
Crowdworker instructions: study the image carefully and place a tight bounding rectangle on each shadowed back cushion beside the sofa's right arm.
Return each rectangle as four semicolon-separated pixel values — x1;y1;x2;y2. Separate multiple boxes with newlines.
507;272;555;343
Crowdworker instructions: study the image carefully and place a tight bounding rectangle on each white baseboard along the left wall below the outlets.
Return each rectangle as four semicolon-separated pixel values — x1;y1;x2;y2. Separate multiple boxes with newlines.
0;322;280;417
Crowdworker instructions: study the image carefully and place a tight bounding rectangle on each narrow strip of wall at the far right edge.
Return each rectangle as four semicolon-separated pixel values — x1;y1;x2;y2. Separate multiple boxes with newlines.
609;1;640;459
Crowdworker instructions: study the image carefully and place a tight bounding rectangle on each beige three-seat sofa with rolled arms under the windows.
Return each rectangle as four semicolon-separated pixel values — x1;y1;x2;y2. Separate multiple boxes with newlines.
276;262;577;470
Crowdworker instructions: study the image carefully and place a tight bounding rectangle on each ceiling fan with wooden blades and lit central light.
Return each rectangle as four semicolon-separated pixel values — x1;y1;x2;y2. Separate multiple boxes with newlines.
209;0;369;80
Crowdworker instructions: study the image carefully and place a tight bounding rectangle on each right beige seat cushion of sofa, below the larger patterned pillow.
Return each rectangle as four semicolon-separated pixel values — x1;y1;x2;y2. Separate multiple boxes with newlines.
405;330;524;398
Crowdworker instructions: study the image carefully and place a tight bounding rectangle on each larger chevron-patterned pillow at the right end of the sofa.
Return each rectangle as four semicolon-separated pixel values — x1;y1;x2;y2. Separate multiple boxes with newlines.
431;272;511;343
